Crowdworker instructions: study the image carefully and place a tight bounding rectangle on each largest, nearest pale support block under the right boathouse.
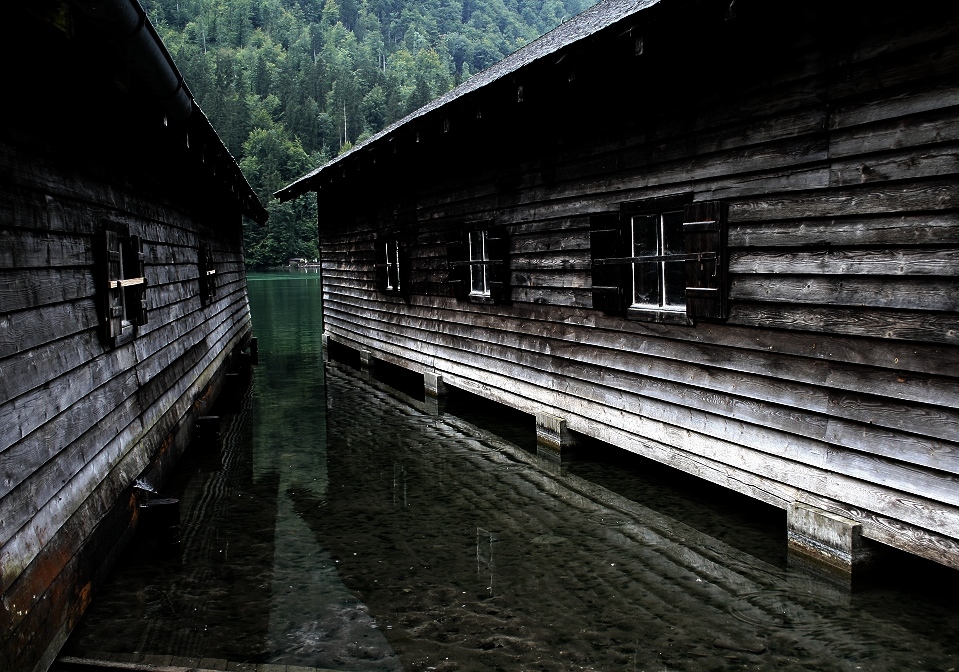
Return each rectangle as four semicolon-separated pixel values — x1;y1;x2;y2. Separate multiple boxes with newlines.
786;502;877;581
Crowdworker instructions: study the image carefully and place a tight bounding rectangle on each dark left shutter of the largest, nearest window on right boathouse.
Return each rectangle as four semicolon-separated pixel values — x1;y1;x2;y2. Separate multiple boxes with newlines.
589;213;631;315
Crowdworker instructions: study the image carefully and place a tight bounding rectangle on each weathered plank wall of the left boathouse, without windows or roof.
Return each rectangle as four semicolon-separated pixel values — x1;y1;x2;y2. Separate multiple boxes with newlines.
0;133;251;670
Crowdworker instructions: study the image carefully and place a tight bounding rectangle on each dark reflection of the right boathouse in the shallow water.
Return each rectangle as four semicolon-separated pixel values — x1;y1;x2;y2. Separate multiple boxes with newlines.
284;362;959;670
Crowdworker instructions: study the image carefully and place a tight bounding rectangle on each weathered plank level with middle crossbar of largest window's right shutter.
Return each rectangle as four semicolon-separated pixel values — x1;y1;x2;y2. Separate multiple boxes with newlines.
729;248;959;276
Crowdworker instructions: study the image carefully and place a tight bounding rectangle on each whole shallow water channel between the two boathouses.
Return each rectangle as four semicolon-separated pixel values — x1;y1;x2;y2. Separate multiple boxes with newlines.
64;274;959;672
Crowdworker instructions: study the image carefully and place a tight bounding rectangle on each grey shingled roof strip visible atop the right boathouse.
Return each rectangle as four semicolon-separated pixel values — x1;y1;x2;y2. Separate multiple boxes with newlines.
274;0;662;201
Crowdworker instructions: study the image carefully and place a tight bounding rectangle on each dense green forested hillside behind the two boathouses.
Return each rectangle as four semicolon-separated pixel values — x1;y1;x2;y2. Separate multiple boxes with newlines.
141;0;595;266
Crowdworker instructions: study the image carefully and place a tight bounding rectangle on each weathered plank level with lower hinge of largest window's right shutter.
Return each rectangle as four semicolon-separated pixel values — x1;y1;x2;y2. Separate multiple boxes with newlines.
729;275;959;311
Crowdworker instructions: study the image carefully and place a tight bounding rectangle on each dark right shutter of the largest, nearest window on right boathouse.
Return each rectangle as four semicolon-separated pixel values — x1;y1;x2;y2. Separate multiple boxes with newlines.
683;201;729;321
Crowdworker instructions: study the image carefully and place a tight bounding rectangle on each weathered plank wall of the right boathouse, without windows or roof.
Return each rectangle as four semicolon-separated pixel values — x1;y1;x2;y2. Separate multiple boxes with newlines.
310;2;959;566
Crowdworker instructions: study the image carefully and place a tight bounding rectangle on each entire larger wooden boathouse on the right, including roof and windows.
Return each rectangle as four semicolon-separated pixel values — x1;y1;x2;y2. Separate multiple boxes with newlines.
277;0;959;572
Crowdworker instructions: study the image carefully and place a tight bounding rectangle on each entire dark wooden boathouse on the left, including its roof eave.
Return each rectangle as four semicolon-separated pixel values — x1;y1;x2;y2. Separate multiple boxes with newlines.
0;0;266;671
